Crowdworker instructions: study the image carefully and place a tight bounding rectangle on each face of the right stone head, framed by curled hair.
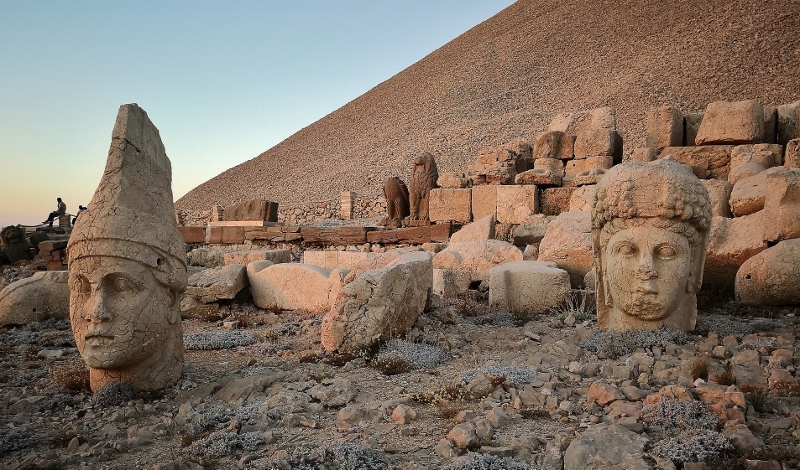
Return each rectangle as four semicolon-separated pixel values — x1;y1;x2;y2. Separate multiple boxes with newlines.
605;225;692;321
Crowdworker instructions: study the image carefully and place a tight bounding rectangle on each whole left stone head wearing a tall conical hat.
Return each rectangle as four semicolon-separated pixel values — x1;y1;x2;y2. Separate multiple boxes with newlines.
67;104;187;390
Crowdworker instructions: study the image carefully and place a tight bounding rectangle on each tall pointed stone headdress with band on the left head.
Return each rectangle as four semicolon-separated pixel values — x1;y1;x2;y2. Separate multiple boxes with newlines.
67;103;186;291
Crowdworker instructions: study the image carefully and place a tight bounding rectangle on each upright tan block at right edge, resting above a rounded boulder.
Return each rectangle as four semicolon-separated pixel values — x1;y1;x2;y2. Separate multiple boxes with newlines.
763;167;800;243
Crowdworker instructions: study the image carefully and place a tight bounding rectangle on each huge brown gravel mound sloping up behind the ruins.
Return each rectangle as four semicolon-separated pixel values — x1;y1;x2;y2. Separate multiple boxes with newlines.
176;0;800;213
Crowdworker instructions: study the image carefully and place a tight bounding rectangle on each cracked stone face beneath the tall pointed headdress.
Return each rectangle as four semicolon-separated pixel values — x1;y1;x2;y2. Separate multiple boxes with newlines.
69;256;178;369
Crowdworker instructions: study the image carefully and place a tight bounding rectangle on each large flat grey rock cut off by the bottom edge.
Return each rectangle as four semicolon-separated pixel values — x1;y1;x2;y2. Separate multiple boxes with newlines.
564;424;653;470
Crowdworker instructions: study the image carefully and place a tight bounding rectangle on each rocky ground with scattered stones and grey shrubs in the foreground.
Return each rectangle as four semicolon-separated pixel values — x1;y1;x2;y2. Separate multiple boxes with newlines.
0;260;800;469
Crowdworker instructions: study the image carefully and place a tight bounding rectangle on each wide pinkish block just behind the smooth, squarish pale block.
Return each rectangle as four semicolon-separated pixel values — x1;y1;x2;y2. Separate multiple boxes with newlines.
433;240;522;281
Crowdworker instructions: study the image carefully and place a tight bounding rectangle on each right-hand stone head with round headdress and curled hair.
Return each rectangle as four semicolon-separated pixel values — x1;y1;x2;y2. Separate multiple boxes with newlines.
592;160;711;331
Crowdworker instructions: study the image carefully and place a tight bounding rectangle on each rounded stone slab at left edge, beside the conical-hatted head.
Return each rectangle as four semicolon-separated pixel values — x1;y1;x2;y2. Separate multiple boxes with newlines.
0;271;69;325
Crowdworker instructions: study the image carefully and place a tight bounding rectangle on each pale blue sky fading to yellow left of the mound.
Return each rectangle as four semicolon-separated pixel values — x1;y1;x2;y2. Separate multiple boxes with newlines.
0;0;513;227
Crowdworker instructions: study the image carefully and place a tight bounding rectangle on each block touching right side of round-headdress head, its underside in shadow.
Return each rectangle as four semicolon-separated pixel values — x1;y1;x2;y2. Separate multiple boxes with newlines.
703;211;767;291
